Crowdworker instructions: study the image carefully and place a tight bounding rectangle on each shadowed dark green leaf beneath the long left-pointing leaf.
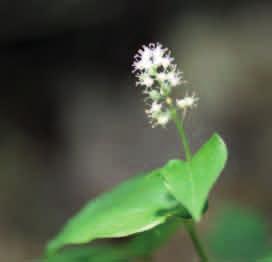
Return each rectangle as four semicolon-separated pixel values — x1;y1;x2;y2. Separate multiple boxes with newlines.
43;218;182;262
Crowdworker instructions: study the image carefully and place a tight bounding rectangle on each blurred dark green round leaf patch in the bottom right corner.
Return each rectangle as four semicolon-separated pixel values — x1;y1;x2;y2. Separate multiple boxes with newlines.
206;206;272;262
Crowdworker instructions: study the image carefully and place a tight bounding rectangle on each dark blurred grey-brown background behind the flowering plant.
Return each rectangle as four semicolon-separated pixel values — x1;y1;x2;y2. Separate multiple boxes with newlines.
0;0;272;262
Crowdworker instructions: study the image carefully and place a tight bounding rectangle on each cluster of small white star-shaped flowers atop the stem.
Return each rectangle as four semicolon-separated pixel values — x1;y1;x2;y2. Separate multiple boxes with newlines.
132;43;198;127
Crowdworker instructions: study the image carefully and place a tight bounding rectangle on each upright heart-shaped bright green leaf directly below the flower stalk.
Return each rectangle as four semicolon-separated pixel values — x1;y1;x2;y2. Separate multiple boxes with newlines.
161;134;227;221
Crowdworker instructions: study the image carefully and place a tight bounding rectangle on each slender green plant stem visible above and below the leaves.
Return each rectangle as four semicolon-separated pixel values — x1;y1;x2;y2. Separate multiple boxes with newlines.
172;109;209;262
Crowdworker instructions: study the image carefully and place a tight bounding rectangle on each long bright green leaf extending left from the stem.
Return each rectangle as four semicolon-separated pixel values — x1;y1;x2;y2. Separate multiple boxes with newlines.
47;170;188;254
